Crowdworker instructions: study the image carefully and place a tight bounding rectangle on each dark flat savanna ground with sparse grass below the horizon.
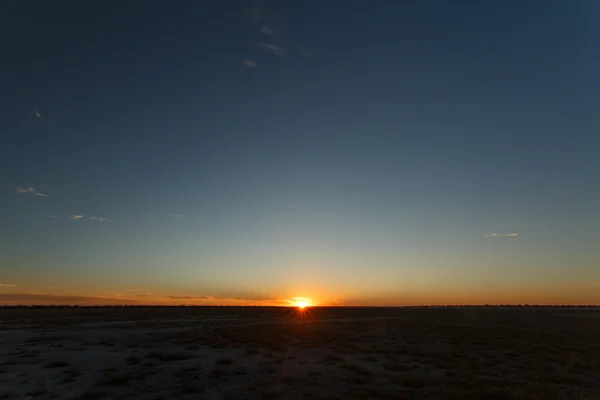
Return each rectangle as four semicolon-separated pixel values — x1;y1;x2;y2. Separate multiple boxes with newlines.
0;307;600;400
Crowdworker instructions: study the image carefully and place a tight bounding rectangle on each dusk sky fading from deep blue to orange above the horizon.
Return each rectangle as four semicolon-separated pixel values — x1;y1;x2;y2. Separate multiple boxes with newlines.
0;0;600;306
